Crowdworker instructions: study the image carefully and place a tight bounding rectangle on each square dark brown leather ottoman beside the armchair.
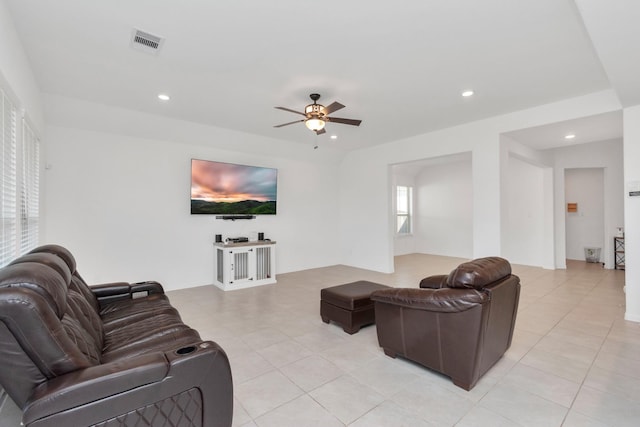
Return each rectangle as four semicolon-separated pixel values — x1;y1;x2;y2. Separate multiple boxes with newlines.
320;280;389;334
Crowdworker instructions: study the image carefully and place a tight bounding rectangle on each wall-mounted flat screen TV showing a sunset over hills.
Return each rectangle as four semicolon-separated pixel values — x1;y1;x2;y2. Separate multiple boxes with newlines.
191;159;278;215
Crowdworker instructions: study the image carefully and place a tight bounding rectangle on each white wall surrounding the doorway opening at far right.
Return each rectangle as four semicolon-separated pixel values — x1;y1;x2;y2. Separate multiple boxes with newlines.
547;140;627;268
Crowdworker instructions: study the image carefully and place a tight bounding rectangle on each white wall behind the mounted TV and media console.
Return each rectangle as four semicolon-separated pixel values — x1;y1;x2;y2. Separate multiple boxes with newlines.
46;98;339;289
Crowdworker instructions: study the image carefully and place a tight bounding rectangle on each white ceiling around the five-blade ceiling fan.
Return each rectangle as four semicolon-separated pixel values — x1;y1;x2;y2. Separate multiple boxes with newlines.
0;0;640;149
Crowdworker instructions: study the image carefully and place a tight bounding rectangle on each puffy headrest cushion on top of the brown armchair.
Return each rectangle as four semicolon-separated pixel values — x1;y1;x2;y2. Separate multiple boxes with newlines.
447;257;511;290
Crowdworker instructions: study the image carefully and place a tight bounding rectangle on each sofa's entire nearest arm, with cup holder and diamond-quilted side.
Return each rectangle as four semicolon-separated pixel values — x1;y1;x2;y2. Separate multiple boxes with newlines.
23;341;233;427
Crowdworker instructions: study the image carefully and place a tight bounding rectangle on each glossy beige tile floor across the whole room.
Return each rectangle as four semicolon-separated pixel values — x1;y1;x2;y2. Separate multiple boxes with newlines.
0;255;640;427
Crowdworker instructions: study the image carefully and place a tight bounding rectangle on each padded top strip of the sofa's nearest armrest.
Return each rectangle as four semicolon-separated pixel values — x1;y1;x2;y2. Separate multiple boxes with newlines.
23;352;169;425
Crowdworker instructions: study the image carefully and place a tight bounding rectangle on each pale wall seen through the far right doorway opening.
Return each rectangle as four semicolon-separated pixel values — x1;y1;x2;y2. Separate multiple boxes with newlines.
564;168;606;262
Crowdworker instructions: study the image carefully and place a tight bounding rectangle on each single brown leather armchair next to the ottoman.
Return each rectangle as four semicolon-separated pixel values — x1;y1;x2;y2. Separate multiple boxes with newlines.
371;257;520;390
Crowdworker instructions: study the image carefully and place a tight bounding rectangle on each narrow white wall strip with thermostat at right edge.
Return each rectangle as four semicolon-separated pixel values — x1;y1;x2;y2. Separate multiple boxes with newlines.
623;106;640;322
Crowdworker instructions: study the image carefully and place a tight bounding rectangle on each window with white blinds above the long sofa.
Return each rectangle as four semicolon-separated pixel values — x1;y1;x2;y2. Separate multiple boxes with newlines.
0;89;40;267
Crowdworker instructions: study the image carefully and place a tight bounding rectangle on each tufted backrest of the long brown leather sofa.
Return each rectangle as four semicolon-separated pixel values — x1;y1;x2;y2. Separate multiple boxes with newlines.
0;253;103;406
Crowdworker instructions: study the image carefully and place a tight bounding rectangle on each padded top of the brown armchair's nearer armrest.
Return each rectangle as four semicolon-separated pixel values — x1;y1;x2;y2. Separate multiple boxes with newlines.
371;288;489;313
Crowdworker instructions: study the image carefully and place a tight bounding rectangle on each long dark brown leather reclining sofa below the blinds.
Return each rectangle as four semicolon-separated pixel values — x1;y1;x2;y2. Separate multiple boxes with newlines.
0;245;233;427
